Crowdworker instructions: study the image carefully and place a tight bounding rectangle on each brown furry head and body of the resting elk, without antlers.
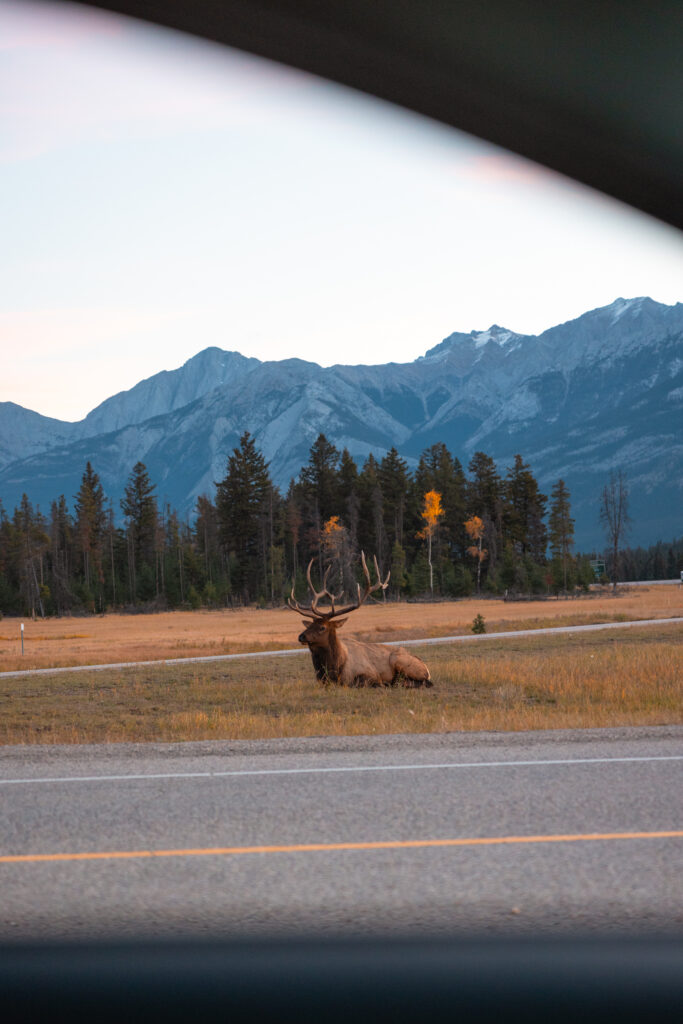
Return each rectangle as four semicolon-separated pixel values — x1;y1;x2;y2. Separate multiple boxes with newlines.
299;618;433;687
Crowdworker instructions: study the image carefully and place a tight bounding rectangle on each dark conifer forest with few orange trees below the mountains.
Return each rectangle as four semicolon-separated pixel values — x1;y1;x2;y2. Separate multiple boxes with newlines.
0;433;683;615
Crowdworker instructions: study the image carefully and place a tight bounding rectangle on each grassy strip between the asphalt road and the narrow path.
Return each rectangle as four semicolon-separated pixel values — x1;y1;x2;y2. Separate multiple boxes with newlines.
0;625;683;744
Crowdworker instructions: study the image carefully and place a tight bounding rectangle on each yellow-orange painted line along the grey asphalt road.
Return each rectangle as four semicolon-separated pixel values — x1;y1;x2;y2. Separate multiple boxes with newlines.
0;829;683;864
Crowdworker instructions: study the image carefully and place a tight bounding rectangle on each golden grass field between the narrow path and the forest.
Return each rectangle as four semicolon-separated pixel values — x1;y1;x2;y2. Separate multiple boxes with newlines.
0;586;683;672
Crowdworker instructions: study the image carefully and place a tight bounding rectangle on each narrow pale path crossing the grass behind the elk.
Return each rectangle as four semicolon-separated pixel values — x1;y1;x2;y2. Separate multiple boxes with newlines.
0;615;683;679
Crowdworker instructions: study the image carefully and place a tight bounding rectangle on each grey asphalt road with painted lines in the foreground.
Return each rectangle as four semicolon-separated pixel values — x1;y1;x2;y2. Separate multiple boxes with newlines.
0;726;683;942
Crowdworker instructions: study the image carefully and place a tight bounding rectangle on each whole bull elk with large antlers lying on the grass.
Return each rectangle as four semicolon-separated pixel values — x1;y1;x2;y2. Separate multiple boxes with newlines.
288;554;433;687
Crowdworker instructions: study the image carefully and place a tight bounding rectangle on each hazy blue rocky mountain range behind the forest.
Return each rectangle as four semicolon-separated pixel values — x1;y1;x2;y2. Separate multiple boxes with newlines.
0;298;683;550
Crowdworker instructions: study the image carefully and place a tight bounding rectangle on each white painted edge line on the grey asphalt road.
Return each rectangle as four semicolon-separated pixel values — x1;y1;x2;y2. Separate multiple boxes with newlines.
0;754;683;785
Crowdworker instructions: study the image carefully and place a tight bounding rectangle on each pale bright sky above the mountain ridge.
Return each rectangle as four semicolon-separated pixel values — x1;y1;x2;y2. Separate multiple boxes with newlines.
0;0;683;420
